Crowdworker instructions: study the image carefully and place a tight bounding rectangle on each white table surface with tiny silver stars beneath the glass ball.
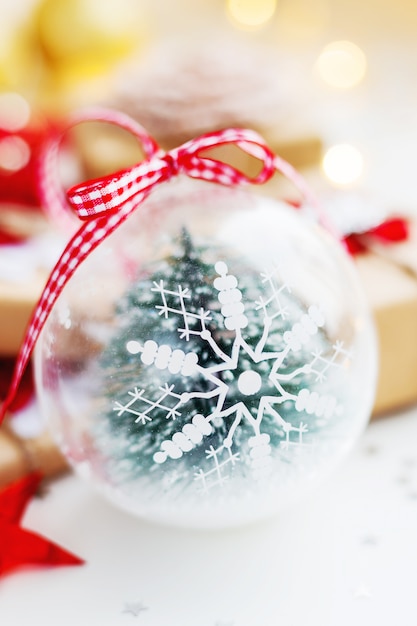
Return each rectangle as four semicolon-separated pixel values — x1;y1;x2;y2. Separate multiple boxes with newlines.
0;408;417;626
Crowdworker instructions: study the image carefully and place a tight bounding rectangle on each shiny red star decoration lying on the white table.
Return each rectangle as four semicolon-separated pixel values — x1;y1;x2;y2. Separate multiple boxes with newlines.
0;472;84;576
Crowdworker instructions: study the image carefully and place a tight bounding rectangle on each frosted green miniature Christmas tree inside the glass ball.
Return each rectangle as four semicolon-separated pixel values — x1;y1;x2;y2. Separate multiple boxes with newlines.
97;231;343;490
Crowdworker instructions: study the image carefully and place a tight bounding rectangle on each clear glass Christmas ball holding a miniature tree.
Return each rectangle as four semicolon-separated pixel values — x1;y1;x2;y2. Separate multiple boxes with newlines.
35;180;377;528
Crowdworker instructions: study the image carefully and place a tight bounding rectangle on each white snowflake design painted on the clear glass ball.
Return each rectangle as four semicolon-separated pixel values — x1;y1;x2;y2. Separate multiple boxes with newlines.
114;261;350;491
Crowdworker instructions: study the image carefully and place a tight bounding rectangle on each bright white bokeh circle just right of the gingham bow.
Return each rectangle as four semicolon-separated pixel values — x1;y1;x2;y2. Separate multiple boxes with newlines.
322;143;364;186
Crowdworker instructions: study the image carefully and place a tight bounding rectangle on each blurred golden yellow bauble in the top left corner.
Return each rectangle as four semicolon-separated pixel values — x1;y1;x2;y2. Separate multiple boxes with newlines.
0;0;152;106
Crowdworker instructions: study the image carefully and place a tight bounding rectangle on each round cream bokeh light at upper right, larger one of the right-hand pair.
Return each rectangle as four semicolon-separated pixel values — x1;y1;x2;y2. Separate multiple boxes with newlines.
316;41;367;89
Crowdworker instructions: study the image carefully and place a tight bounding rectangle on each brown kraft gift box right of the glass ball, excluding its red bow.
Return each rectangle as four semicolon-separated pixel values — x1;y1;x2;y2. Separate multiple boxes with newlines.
355;222;417;415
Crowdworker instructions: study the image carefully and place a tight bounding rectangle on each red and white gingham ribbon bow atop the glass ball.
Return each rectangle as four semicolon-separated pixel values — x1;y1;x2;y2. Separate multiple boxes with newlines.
0;109;317;423
